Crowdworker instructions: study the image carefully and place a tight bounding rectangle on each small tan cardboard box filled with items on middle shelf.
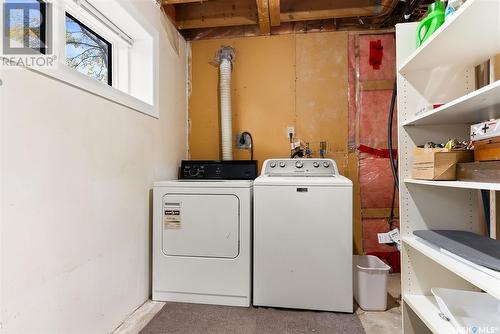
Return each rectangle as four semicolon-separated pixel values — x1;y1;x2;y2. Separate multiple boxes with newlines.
412;147;474;181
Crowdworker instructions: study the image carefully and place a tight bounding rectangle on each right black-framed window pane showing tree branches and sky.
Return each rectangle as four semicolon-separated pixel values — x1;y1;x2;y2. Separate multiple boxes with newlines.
66;13;113;86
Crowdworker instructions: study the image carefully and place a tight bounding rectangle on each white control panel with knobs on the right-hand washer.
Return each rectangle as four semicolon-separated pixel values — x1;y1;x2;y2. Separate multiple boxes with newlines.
262;159;339;177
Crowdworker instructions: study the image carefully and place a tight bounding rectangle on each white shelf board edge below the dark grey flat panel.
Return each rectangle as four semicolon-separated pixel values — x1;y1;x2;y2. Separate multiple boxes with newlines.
402;237;500;299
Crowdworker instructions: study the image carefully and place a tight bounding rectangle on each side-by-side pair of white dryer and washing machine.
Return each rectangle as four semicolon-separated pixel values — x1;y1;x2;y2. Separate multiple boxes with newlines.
153;159;353;312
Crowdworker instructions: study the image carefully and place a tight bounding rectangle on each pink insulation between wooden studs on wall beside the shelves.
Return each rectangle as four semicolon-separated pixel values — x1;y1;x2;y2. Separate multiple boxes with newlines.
348;33;398;253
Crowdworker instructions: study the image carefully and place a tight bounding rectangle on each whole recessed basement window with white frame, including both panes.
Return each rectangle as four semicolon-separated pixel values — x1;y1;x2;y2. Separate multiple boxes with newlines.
5;0;160;117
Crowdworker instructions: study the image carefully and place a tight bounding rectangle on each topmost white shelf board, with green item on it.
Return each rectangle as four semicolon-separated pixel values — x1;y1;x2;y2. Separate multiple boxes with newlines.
399;0;500;75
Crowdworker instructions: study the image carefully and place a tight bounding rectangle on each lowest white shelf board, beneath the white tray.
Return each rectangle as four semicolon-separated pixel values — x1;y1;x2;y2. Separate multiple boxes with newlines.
403;295;456;334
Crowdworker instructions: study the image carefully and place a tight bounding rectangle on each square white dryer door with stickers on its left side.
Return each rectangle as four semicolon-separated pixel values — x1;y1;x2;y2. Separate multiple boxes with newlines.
162;194;240;258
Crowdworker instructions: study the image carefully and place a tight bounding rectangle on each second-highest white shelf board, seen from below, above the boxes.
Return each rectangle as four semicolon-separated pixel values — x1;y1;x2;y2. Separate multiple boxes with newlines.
403;80;500;126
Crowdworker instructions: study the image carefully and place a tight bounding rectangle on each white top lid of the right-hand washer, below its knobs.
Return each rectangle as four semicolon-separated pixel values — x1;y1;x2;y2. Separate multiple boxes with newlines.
254;175;352;187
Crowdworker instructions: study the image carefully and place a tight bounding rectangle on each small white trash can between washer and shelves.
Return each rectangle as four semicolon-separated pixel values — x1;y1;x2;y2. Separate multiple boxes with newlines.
353;255;391;311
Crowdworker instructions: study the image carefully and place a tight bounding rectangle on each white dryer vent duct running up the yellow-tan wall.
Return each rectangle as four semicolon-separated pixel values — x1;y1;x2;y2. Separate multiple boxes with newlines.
215;46;235;160
